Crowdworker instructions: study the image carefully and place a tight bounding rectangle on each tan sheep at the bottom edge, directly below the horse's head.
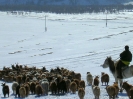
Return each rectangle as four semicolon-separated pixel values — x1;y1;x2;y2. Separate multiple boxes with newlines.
105;86;116;99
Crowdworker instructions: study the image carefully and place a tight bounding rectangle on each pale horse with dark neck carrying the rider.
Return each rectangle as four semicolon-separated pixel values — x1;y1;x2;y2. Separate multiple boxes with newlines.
101;57;133;92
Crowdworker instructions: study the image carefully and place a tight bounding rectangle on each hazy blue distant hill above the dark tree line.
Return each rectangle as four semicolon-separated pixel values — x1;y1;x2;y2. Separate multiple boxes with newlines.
0;0;133;5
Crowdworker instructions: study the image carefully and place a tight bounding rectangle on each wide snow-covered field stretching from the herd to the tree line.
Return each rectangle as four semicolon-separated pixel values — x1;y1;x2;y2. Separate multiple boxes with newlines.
0;12;133;99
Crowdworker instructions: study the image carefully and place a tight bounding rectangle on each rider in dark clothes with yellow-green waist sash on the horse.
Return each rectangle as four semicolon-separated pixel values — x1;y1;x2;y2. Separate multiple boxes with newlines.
117;45;132;79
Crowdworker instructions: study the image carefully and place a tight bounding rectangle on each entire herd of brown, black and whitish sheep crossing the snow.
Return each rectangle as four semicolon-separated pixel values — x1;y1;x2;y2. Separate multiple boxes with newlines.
0;64;133;99
